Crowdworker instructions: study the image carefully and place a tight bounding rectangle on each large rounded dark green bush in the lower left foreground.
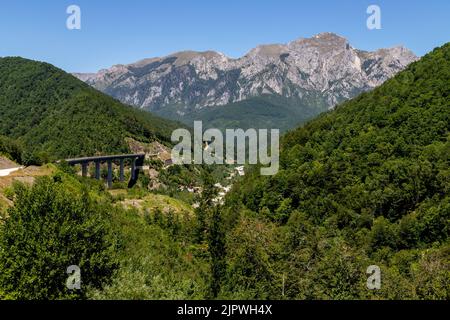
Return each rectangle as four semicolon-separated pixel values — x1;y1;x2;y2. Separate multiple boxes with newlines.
0;177;116;299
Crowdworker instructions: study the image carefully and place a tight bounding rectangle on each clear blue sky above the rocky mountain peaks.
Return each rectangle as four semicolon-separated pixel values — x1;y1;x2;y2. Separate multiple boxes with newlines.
0;0;450;72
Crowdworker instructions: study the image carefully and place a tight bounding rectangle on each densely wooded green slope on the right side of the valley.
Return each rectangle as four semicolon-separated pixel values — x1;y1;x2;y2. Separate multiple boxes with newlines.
222;44;450;299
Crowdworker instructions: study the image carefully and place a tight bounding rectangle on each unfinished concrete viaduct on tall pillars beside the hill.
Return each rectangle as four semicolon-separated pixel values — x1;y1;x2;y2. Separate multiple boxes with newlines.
66;154;145;188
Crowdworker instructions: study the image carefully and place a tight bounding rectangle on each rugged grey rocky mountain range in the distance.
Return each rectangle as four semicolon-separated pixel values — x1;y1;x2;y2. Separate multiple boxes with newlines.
75;33;417;129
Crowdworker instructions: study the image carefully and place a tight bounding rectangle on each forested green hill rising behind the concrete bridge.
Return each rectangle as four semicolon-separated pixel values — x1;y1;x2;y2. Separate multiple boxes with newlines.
0;58;180;164
